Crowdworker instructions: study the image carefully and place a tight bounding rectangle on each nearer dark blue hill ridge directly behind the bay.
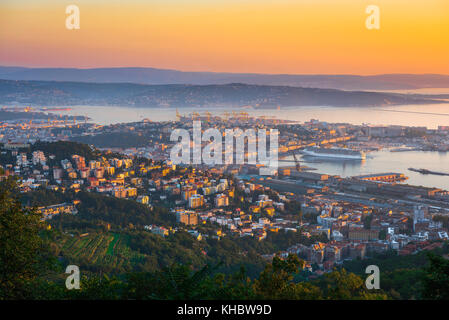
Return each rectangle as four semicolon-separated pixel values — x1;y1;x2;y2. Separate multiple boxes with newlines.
0;80;443;108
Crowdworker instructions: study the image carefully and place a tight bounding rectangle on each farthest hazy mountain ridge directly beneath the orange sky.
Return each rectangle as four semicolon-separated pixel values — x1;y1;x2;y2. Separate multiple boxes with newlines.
0;67;449;90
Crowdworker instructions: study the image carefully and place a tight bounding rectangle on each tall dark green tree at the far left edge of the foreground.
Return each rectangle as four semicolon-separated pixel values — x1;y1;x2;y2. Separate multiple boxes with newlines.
0;177;44;299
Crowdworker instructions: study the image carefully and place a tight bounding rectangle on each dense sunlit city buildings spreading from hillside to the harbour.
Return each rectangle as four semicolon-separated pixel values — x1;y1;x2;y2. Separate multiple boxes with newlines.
0;108;449;275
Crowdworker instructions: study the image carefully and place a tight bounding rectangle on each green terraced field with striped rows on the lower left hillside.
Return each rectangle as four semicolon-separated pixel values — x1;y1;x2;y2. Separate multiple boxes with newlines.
60;233;145;271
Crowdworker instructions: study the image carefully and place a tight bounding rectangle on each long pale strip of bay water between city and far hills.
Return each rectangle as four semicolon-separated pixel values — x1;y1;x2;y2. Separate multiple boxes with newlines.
58;103;449;128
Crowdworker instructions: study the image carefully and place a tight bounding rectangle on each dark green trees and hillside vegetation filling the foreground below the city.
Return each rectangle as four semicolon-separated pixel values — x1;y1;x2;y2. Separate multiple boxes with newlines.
0;172;449;300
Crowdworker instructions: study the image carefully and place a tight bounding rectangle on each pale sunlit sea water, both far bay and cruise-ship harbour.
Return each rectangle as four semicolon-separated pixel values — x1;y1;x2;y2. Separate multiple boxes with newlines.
43;100;449;190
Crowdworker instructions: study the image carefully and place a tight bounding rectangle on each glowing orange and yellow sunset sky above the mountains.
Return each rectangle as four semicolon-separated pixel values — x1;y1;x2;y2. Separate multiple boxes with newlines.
0;0;449;74
